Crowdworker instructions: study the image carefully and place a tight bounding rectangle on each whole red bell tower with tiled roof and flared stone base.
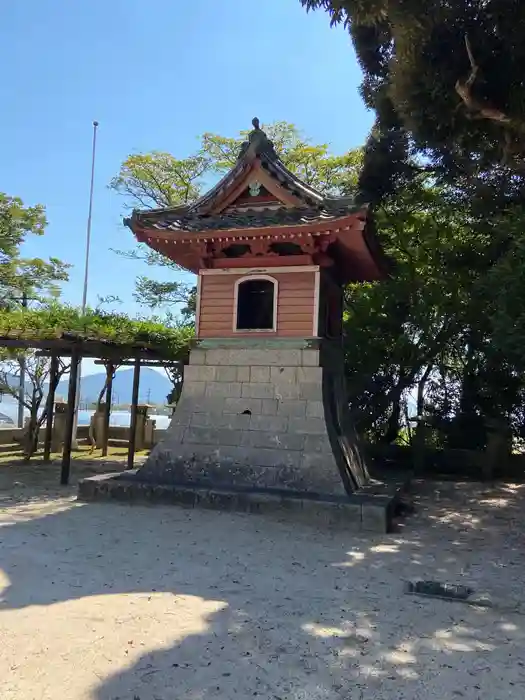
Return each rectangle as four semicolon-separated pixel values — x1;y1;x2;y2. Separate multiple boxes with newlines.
121;119;392;524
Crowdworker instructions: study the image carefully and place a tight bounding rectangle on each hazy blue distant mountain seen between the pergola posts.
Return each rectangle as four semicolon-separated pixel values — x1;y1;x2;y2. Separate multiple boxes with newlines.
56;367;172;404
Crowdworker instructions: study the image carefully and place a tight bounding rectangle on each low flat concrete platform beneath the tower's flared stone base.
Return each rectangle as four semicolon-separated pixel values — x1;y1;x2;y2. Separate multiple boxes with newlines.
78;470;408;533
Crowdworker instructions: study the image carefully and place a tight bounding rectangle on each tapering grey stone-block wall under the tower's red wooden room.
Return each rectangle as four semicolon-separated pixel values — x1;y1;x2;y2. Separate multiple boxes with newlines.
133;339;366;496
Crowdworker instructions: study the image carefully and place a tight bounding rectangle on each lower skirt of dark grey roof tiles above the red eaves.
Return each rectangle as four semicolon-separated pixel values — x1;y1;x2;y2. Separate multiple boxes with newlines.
132;198;360;232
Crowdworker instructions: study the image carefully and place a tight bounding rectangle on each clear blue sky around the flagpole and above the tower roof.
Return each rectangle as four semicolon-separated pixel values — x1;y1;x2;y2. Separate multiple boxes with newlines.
0;0;372;372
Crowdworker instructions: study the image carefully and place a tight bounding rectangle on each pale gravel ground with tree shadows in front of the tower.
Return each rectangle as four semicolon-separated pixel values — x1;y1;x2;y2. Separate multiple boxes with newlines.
0;462;525;700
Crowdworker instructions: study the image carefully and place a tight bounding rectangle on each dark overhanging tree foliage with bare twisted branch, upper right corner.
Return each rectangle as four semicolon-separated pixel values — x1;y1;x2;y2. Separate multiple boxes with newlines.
301;0;525;196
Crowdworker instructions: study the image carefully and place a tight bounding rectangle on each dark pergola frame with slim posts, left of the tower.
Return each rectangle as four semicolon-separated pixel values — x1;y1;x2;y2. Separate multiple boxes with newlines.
0;332;181;485
